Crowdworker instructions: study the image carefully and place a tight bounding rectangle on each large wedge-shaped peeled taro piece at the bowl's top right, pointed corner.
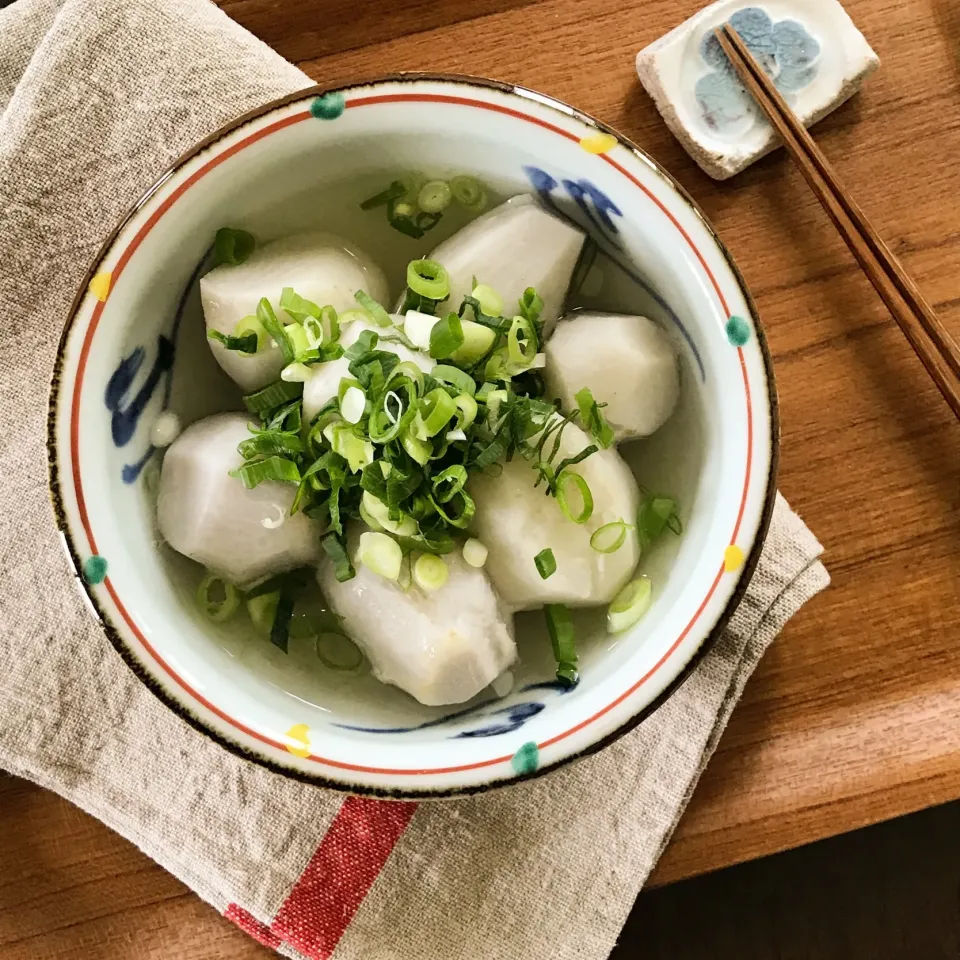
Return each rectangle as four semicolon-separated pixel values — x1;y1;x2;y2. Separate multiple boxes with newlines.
430;194;585;337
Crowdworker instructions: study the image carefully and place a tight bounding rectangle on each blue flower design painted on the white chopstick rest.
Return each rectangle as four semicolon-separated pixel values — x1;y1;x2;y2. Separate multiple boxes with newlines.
695;7;820;135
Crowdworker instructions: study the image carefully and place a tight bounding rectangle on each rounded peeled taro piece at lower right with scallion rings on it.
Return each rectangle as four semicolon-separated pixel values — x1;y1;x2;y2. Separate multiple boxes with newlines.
467;423;640;610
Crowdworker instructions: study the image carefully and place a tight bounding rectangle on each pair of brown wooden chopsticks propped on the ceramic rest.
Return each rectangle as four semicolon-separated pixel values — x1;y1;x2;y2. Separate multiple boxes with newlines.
714;23;960;419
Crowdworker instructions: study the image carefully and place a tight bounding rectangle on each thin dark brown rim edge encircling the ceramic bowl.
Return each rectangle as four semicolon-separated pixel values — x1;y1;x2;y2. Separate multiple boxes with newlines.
46;71;780;800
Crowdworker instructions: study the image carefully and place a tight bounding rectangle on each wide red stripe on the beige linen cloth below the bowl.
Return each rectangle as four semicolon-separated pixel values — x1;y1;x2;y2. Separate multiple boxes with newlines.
270;797;417;960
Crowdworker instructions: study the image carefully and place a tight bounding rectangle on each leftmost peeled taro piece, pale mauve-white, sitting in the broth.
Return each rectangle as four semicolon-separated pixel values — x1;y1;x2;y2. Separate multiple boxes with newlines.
157;413;320;588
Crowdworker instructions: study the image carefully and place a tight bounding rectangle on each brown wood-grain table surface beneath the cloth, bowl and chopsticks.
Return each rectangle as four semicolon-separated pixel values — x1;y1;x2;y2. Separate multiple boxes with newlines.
0;0;960;960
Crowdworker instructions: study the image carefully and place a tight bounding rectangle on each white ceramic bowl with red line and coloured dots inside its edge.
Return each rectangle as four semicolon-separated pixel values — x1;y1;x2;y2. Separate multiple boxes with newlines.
49;75;777;797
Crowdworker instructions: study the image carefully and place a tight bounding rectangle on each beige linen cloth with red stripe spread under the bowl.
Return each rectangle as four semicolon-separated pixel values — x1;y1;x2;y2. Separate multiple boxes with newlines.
0;0;828;960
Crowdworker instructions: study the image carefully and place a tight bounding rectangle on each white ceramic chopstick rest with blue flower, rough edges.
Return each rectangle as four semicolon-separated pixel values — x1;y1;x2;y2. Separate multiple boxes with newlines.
637;0;880;180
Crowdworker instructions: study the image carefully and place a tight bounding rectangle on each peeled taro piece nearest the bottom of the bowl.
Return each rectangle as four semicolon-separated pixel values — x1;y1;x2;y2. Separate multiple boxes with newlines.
317;524;517;706
